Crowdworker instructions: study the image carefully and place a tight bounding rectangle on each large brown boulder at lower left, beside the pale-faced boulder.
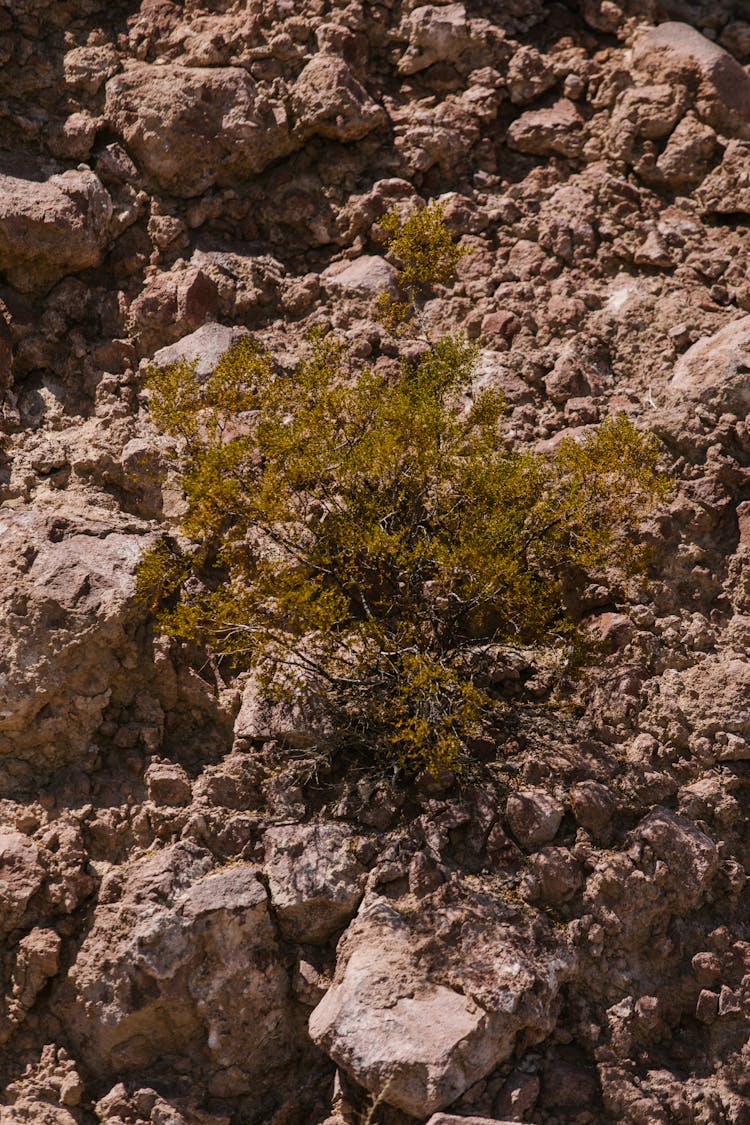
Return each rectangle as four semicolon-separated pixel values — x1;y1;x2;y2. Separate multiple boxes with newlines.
65;842;295;1103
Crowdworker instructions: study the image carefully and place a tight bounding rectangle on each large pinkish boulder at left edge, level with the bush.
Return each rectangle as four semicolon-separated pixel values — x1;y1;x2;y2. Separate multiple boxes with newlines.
0;503;150;771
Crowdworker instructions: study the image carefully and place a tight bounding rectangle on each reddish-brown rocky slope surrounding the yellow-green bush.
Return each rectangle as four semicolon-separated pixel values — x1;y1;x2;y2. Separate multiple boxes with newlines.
0;0;750;1125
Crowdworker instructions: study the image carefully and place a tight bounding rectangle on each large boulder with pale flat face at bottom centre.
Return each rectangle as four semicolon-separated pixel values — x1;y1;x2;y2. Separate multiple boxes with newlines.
309;884;570;1119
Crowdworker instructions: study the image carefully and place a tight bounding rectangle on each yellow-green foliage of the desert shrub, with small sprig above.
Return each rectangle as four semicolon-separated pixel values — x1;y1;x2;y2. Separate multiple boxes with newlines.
141;204;667;771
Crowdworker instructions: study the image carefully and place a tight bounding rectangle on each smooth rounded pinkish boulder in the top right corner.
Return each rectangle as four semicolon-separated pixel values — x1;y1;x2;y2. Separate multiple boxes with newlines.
633;21;750;136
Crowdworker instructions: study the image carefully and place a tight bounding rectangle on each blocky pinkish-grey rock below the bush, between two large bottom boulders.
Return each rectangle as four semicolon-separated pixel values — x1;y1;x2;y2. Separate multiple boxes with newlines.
263;825;367;945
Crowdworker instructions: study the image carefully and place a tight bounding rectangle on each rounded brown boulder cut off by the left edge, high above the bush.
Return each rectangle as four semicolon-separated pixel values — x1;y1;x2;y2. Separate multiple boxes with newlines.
0;170;112;291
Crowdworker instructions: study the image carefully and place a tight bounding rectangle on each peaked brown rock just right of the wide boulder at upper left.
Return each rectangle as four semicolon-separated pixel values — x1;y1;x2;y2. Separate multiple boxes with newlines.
291;55;386;144
